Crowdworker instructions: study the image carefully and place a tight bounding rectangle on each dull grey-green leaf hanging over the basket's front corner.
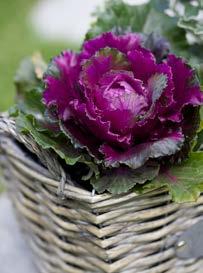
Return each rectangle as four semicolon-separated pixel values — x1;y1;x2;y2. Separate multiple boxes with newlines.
91;163;159;194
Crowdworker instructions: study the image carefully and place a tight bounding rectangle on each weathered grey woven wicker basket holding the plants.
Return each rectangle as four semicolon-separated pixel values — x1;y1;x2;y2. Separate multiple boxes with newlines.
0;113;203;273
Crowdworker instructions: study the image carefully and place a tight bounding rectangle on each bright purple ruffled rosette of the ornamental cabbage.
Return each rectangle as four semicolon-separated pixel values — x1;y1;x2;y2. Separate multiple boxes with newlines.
43;32;203;169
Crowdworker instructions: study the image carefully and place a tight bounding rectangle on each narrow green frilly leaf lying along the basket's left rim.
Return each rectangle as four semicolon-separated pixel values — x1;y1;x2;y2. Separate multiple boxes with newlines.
16;113;81;165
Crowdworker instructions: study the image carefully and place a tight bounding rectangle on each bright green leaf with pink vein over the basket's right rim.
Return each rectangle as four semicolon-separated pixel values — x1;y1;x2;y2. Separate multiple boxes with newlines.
136;152;203;203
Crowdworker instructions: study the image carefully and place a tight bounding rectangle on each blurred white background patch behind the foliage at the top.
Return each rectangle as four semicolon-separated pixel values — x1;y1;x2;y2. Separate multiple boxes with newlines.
31;0;148;43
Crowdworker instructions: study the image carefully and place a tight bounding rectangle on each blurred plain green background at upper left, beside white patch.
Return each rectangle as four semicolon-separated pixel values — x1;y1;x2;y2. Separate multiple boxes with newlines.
0;0;76;112
